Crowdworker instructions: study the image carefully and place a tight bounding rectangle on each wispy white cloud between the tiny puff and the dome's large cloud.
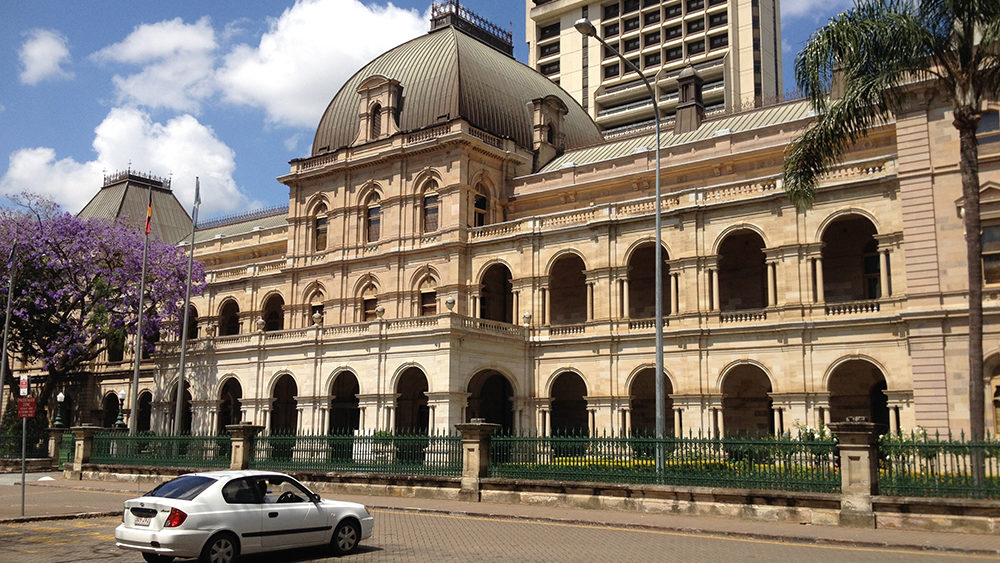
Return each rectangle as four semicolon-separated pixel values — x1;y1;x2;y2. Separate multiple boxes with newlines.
92;17;218;113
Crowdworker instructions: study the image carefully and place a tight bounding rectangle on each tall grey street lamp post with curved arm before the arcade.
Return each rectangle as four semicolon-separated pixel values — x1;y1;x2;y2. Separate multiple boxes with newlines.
573;18;667;471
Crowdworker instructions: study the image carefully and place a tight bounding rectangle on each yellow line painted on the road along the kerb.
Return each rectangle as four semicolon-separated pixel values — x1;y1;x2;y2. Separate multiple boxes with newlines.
373;509;996;561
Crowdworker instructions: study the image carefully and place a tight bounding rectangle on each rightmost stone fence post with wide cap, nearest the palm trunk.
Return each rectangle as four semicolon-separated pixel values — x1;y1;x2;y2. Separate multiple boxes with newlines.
830;417;886;528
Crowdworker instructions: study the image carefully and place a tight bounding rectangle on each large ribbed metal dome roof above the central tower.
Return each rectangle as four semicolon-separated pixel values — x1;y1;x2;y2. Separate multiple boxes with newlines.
312;26;602;156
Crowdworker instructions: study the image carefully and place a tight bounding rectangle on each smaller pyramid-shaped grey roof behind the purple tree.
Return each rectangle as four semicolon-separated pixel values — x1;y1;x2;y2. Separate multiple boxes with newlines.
77;170;191;244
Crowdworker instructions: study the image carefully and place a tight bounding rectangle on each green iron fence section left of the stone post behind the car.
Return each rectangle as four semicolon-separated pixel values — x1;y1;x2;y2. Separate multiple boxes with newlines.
90;433;232;468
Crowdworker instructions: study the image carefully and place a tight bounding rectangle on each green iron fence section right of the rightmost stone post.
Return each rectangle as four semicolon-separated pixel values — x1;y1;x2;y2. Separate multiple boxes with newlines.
878;432;1000;499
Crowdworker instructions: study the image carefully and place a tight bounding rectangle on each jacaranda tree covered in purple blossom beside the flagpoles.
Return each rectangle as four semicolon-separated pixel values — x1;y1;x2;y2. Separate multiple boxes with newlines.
0;194;205;418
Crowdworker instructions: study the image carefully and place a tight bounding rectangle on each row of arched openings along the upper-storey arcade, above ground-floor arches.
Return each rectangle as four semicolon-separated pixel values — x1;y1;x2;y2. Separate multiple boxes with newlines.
199;214;890;336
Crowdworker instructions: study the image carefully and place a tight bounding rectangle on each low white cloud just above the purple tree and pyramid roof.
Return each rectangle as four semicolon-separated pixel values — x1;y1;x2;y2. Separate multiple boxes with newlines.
0;108;248;217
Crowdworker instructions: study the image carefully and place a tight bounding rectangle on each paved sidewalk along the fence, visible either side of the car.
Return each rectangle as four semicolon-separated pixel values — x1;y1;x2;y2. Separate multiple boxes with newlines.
0;474;1000;556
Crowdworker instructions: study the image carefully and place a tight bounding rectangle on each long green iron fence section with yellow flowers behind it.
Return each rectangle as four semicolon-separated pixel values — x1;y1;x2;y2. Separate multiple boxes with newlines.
488;435;840;493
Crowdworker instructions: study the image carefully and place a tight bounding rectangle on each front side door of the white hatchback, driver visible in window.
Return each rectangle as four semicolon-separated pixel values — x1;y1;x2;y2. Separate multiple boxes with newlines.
261;476;331;549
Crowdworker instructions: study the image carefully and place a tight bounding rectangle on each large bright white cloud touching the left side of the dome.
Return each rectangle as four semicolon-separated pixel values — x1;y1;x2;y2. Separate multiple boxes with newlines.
217;0;428;127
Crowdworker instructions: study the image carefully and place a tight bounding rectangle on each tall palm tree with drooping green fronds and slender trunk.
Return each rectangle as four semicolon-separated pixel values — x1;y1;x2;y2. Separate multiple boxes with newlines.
784;0;1000;454
